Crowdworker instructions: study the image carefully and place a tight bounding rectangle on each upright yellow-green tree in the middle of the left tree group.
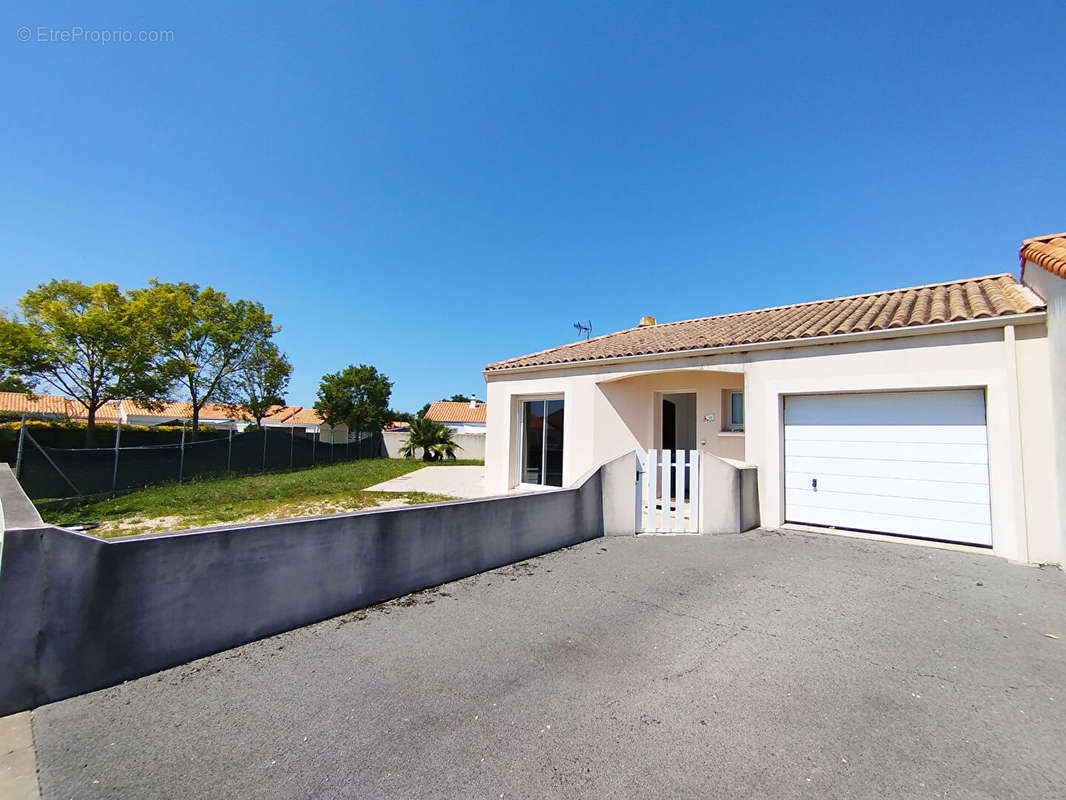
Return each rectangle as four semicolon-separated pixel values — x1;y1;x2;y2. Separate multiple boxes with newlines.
133;281;281;438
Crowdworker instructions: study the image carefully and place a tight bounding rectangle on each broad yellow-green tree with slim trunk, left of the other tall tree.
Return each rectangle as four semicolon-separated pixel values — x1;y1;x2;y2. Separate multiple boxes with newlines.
0;281;167;447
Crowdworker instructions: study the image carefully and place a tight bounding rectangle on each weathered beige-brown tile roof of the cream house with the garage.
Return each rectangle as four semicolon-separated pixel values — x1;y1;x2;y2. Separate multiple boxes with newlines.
485;274;1045;372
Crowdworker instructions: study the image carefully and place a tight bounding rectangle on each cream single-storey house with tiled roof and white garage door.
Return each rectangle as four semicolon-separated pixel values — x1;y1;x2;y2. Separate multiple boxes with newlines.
484;235;1066;563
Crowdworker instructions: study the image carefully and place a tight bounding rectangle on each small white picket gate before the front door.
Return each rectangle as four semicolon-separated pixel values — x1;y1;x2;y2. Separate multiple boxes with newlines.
636;450;701;533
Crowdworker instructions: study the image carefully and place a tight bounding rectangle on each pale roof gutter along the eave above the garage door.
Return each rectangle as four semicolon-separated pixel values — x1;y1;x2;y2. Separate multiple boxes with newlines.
482;311;1048;380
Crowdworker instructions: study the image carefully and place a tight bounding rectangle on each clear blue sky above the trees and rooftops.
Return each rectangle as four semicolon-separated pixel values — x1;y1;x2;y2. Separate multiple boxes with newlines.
0;0;1066;410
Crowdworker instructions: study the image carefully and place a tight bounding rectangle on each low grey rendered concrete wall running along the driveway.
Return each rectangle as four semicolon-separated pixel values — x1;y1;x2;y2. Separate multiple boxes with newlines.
0;462;603;716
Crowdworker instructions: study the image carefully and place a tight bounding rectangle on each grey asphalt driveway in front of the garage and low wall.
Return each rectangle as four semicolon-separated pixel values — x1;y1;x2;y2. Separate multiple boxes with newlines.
34;532;1066;798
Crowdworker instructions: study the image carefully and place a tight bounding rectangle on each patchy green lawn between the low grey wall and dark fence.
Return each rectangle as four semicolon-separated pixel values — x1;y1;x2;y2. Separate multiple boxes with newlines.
42;459;483;537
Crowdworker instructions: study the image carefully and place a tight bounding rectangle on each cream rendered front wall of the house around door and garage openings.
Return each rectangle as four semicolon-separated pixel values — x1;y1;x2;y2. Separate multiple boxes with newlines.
485;315;1066;562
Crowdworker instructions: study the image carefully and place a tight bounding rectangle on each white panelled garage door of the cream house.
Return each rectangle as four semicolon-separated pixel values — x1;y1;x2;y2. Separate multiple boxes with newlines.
785;389;992;547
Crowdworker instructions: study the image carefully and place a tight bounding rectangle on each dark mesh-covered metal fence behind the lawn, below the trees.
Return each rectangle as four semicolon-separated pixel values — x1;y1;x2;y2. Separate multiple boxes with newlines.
15;426;386;500
